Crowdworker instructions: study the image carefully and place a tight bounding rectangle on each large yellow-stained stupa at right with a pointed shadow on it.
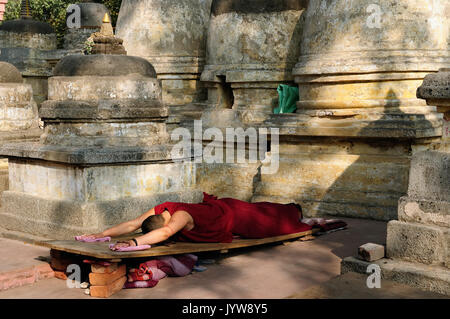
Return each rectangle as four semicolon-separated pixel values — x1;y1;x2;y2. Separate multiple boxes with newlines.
254;0;450;220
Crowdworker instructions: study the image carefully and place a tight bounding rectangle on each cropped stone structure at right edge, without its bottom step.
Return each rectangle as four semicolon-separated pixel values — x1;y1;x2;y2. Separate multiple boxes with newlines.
387;69;450;270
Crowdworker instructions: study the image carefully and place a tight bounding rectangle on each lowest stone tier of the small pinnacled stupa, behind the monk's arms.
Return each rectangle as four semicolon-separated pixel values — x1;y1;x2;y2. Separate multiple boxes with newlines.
0;190;203;240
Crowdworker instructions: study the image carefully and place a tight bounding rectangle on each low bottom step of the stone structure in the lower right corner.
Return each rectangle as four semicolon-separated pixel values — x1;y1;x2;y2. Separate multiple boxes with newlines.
341;257;450;296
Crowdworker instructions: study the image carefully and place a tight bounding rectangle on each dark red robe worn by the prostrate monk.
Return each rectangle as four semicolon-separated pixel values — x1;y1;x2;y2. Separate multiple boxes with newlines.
155;194;312;243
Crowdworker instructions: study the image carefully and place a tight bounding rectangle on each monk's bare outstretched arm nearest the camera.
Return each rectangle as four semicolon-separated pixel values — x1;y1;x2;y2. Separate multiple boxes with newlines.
113;211;192;250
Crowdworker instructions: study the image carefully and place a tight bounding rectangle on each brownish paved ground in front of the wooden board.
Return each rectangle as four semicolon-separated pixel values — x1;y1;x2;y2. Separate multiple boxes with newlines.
0;219;441;299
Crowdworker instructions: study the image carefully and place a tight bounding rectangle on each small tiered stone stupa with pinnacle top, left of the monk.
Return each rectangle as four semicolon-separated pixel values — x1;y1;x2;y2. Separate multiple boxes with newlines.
0;16;202;239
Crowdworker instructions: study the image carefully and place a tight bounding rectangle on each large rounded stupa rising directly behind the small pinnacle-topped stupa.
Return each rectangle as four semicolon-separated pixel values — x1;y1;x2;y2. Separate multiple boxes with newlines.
116;0;212;105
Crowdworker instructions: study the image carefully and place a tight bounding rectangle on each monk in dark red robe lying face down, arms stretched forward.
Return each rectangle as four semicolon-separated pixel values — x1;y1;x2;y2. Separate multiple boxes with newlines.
80;194;324;250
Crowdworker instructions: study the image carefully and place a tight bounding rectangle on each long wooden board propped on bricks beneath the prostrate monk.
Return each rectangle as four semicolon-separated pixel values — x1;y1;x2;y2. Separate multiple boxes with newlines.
39;229;319;260
